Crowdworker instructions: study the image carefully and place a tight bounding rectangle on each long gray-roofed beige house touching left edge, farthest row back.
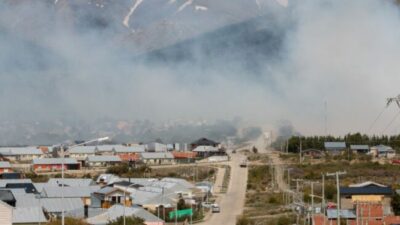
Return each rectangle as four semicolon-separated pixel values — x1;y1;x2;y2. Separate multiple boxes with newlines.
0;147;43;161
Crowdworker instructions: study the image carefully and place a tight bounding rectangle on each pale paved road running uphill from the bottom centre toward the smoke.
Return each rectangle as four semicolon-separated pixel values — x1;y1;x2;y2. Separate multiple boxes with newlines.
199;153;247;225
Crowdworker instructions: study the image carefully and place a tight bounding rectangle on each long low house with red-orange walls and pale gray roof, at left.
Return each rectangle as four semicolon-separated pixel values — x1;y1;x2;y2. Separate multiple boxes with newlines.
32;158;80;172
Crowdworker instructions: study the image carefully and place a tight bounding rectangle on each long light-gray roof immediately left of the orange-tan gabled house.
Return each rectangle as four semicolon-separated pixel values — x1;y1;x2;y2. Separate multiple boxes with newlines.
42;186;100;198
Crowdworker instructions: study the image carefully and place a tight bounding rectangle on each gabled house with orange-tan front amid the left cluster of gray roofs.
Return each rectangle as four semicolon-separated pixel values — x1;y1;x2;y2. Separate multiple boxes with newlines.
91;186;132;209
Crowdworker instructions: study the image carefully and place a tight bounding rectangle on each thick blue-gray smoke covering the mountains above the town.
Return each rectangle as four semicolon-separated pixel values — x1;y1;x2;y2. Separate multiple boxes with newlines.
0;0;400;145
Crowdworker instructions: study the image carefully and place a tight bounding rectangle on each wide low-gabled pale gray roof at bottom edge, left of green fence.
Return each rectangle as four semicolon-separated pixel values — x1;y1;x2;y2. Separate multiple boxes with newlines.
86;205;165;225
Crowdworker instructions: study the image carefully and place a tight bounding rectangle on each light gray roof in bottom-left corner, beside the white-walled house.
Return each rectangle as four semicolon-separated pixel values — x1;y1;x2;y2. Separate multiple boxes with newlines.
12;207;47;224
